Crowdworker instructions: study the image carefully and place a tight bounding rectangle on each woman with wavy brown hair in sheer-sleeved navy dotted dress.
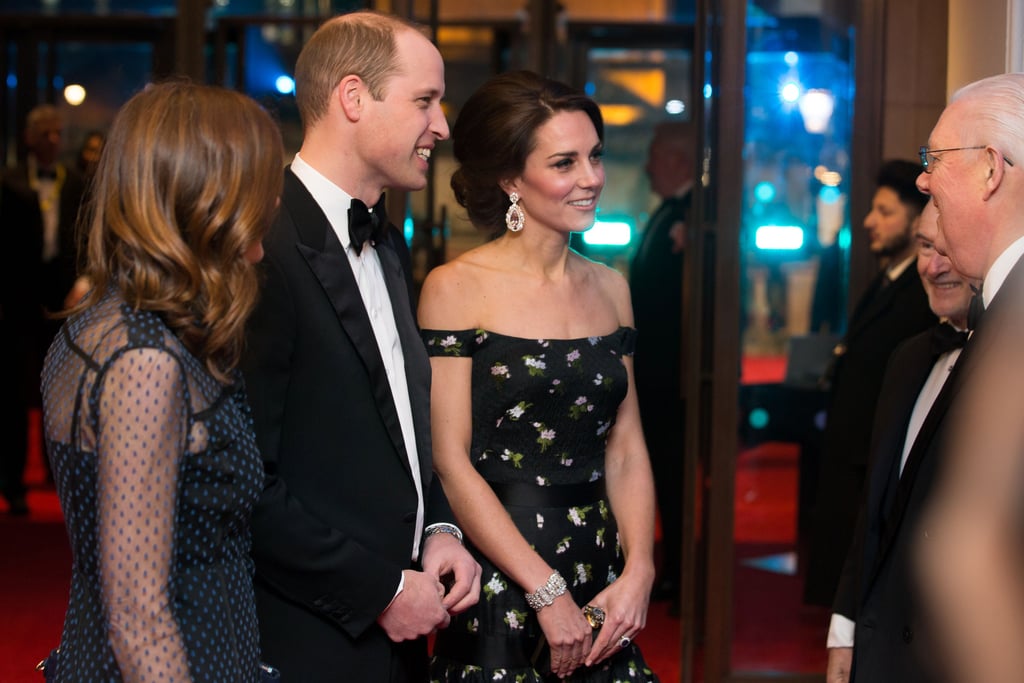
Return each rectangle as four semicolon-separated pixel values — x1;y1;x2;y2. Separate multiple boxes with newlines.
42;82;283;681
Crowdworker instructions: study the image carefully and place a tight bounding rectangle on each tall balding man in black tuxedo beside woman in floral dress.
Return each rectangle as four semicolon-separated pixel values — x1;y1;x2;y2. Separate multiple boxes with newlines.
244;11;480;683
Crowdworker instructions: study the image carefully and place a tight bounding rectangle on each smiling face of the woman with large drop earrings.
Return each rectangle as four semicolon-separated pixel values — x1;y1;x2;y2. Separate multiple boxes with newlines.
505;112;604;231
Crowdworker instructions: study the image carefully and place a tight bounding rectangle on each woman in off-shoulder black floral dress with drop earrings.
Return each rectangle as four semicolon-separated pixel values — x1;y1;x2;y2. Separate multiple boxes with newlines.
420;72;657;683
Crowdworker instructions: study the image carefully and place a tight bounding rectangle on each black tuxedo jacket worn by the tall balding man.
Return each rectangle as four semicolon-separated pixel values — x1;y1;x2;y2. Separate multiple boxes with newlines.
244;169;452;681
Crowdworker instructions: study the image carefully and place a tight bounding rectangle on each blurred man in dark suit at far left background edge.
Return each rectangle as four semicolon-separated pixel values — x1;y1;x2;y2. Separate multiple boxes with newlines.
0;104;84;514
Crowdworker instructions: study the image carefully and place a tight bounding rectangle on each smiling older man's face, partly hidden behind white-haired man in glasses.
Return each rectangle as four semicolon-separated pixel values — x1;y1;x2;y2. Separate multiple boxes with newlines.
914;202;974;330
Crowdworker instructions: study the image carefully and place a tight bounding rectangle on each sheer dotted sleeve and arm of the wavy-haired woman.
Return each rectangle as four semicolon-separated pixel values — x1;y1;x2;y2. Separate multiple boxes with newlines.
96;348;190;683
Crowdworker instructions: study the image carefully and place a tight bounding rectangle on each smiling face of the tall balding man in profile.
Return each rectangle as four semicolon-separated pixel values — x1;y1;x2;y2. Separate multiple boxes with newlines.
357;29;449;194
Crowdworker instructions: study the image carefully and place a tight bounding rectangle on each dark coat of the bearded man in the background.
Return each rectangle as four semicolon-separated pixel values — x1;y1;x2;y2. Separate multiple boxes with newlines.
805;263;937;605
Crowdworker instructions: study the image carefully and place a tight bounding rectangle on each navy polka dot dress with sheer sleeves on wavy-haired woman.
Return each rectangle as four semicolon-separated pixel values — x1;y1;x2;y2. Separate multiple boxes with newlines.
42;296;263;683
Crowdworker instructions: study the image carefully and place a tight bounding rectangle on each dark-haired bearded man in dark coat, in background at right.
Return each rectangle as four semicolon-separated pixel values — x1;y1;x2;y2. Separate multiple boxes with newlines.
804;160;936;605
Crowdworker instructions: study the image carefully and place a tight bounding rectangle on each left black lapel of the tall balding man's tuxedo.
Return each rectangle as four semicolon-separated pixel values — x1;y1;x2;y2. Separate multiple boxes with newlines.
284;170;412;476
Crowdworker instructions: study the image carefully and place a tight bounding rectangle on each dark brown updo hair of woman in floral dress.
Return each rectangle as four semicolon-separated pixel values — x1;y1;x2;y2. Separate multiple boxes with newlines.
452;71;604;233
